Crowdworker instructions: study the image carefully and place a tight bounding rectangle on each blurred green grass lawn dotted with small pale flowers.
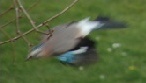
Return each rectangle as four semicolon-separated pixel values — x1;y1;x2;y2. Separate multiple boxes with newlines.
0;0;146;83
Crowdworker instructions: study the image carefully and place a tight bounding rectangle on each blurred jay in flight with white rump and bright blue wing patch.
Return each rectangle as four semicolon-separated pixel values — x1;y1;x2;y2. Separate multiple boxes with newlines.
27;16;126;65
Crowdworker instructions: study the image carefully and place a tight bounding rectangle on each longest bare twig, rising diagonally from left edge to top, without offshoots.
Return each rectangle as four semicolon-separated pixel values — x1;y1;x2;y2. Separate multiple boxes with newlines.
0;0;79;45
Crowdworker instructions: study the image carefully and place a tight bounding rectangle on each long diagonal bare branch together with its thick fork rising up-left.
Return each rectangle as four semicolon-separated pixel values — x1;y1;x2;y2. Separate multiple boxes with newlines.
0;0;79;45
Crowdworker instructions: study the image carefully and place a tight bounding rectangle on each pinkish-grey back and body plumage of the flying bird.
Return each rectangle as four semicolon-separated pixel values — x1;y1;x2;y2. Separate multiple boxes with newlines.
43;23;81;53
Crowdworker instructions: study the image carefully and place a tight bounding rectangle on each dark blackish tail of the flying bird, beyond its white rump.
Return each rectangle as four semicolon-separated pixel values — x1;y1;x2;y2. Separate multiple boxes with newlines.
95;16;127;29
